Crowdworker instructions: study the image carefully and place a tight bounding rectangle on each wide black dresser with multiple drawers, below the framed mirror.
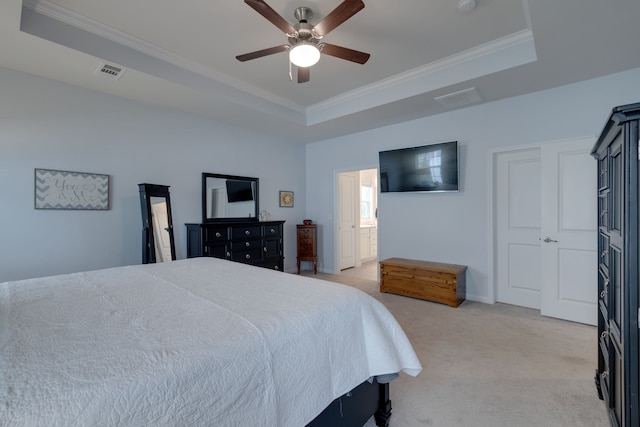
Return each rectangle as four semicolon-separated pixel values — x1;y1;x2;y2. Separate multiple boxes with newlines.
185;221;284;271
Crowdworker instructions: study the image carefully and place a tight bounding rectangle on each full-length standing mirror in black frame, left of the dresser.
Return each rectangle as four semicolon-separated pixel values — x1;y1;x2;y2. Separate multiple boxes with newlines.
138;184;176;264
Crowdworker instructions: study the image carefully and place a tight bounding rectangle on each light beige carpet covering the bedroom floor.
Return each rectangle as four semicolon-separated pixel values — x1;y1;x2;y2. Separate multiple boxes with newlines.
302;262;609;427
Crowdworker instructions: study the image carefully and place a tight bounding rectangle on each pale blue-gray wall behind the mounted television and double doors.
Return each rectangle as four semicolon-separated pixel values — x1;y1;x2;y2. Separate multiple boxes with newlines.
306;69;640;301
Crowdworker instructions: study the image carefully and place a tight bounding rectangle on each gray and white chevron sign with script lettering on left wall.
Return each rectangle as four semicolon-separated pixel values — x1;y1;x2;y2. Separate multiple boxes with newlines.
35;169;109;210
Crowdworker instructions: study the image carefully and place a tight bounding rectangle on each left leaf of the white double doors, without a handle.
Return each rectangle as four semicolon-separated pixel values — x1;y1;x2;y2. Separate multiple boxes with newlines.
494;148;541;309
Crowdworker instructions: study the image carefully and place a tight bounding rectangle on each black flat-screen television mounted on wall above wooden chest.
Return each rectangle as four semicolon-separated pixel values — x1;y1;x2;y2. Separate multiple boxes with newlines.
379;141;459;193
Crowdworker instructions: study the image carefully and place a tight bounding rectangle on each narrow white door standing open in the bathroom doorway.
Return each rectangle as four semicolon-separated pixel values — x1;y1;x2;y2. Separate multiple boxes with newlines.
338;173;357;270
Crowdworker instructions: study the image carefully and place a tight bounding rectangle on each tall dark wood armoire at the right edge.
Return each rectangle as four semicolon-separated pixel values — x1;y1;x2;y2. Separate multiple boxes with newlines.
591;103;640;427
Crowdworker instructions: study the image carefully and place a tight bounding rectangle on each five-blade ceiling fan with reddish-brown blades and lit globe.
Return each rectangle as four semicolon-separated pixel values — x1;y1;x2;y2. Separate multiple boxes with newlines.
236;0;371;83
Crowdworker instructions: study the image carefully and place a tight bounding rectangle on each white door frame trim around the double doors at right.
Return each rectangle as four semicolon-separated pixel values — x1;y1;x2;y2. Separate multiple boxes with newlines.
487;135;595;304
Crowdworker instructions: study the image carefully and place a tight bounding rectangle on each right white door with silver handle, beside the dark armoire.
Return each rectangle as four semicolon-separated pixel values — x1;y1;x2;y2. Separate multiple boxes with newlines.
541;138;598;325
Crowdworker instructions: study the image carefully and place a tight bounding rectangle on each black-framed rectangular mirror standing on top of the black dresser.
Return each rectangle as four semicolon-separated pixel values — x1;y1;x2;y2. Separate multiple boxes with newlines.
202;172;260;222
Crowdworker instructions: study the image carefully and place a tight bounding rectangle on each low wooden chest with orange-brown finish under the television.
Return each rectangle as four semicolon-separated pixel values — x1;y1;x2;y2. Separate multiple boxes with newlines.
380;258;467;307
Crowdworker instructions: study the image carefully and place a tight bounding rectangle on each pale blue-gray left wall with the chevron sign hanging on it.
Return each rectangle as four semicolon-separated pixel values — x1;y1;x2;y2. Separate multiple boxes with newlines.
0;68;305;282
